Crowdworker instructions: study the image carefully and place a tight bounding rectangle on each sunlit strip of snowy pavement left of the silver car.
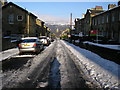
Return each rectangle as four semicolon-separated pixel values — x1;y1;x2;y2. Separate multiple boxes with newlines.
0;48;19;61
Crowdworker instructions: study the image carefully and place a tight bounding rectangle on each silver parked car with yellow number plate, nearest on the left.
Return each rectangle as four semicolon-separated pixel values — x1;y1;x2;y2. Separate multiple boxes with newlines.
18;37;44;54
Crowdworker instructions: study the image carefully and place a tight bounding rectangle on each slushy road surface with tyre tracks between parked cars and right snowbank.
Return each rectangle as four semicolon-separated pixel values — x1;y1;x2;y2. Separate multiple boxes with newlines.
2;40;99;89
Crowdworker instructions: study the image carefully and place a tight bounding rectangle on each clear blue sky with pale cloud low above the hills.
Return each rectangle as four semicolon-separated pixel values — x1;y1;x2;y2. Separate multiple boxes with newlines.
8;0;117;23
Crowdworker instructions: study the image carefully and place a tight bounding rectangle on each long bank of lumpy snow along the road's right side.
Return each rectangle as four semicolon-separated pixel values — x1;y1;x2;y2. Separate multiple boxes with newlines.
61;41;120;89
